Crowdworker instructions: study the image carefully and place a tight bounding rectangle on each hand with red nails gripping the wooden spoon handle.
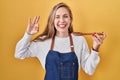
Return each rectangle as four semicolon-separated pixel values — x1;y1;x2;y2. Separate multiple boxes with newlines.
92;32;106;51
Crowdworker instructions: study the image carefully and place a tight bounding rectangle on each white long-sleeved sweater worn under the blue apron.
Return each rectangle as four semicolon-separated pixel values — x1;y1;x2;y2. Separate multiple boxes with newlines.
15;33;100;75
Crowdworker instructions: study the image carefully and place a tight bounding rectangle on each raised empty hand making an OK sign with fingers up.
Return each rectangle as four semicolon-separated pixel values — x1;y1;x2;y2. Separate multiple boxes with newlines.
26;16;40;35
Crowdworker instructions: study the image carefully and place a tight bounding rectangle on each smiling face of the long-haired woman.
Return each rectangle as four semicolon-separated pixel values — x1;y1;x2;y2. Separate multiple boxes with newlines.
54;7;71;33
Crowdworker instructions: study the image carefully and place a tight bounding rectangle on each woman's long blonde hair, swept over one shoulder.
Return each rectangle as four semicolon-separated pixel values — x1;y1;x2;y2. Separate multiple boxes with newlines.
33;2;73;41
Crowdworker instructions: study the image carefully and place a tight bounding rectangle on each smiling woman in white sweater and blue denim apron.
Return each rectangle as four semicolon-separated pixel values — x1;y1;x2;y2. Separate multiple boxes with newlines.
15;3;106;80
